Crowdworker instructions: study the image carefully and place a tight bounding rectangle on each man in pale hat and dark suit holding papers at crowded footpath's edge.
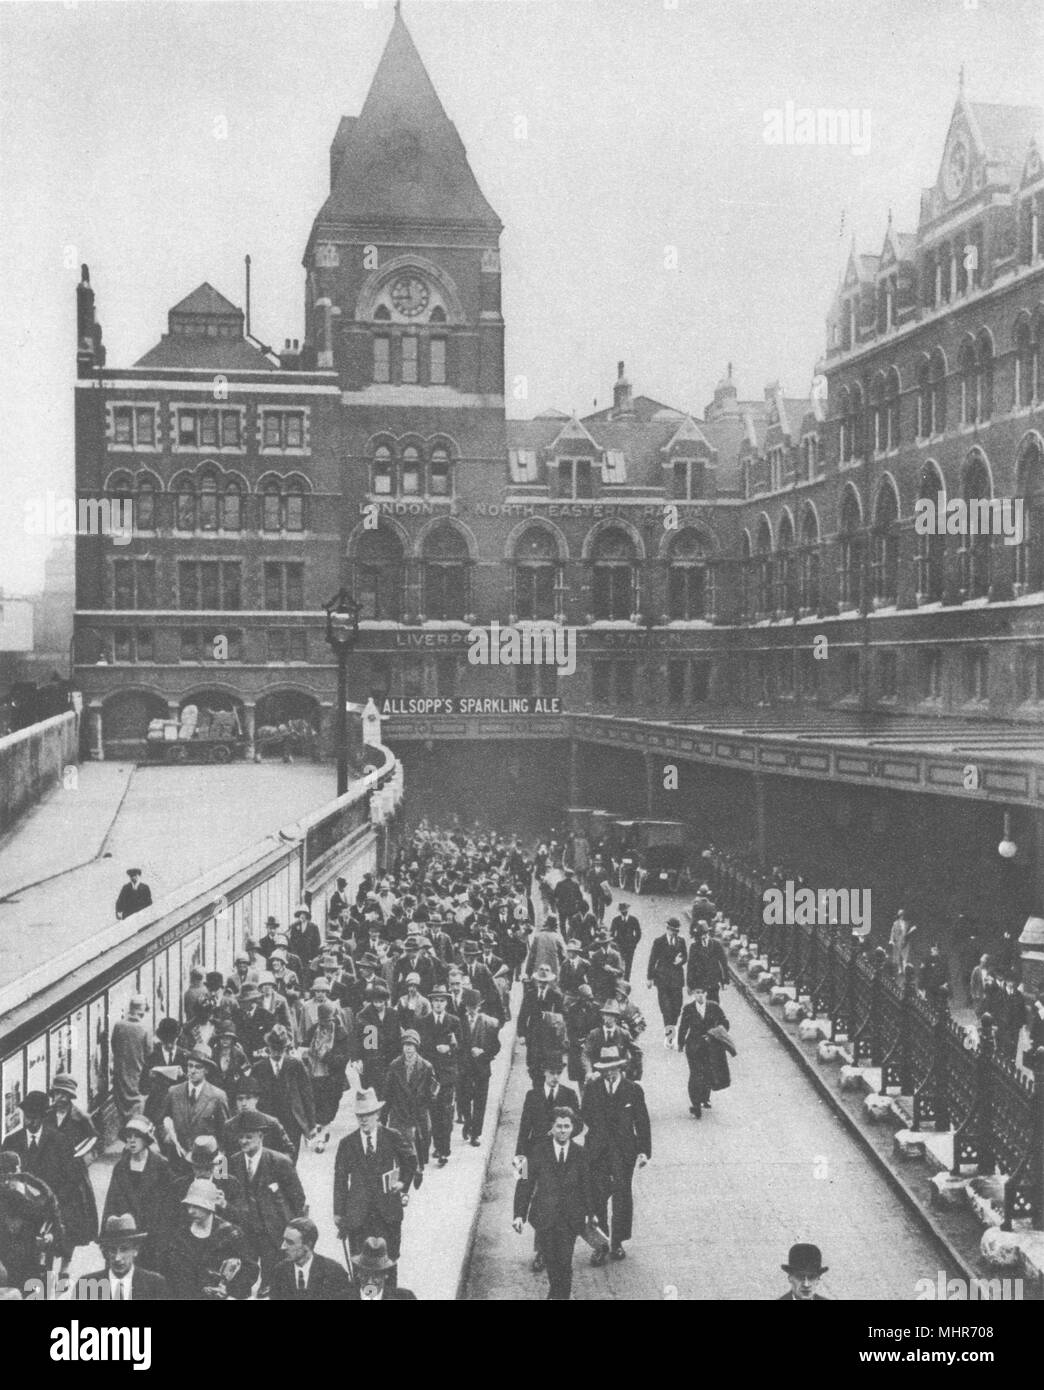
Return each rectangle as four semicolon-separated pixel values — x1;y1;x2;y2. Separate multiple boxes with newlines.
334;1087;417;1259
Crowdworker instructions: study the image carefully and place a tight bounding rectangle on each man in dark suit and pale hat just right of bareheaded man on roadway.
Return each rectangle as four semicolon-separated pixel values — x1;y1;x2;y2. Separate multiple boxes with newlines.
581;1047;652;1265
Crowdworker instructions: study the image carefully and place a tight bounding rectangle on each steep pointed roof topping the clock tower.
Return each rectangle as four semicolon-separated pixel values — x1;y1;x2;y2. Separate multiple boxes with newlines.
318;10;500;231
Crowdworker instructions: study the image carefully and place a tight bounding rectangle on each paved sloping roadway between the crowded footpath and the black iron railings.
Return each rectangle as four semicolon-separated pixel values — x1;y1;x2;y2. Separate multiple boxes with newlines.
466;897;959;1301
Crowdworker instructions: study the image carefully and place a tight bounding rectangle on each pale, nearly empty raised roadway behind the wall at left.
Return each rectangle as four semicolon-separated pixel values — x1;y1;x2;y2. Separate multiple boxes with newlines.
0;763;343;988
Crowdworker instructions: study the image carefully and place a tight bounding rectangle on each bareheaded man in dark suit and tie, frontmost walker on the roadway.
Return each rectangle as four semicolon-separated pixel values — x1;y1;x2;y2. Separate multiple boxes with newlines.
512;1106;596;1302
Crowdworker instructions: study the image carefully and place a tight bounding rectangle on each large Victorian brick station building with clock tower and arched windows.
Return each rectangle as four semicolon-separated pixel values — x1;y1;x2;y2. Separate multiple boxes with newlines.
76;13;1044;934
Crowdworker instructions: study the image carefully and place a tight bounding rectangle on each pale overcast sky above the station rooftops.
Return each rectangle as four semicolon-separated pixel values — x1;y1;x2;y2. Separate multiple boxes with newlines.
0;0;1044;592
